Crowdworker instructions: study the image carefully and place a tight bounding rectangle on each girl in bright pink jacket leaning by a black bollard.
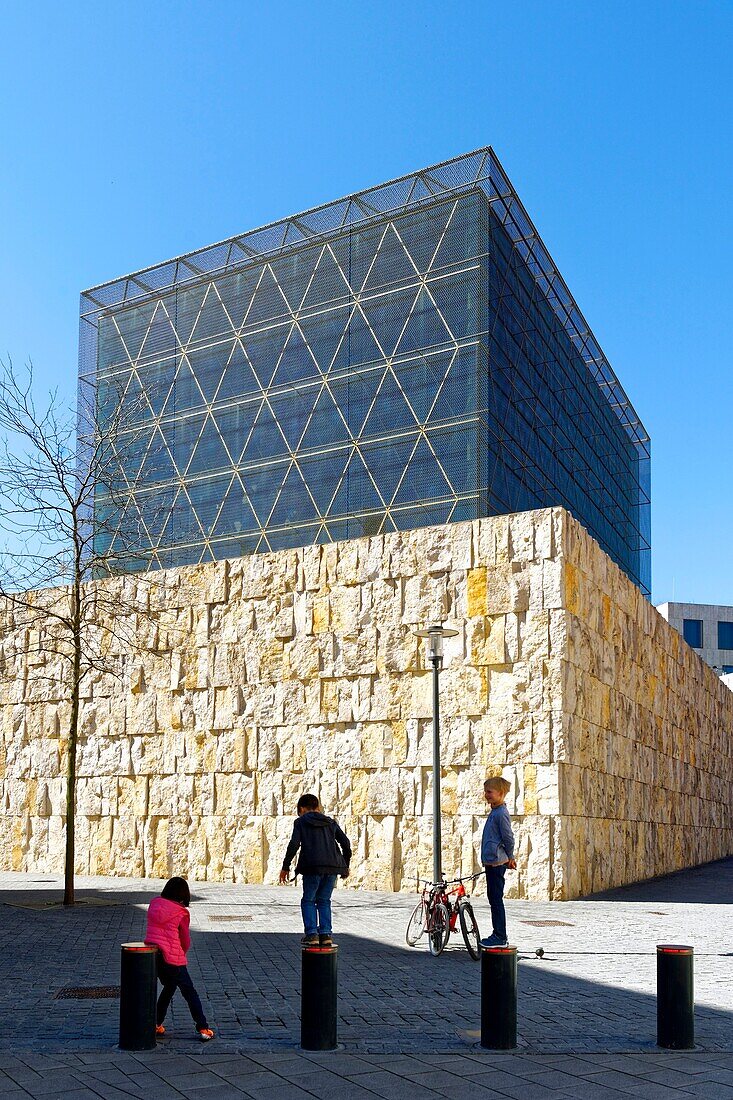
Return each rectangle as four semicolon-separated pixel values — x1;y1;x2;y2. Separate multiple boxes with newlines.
145;878;214;1042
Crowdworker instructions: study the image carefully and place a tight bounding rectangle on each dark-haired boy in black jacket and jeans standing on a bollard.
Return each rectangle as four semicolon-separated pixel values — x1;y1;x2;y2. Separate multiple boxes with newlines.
280;794;351;947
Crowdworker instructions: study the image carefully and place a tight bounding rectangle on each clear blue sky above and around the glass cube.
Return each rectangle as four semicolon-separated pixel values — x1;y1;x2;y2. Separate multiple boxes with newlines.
0;0;733;604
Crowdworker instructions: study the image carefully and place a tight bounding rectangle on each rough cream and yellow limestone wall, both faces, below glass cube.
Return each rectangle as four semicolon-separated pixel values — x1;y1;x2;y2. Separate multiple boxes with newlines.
0;509;733;899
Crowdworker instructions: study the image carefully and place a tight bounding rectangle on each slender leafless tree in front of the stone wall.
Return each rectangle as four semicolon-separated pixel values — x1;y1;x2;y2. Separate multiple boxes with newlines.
0;362;157;905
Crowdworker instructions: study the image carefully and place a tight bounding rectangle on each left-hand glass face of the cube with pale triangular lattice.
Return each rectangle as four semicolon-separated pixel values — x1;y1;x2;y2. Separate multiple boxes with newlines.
94;196;481;565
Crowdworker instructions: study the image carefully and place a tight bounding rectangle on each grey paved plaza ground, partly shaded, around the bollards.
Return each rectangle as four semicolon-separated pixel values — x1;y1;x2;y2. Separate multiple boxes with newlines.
0;859;733;1100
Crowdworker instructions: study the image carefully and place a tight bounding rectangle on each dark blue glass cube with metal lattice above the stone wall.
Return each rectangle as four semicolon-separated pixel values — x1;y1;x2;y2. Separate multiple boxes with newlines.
79;149;650;594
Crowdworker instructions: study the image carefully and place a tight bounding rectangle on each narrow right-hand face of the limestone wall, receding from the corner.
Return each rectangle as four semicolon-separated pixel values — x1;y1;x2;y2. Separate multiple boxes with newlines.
555;517;733;898
